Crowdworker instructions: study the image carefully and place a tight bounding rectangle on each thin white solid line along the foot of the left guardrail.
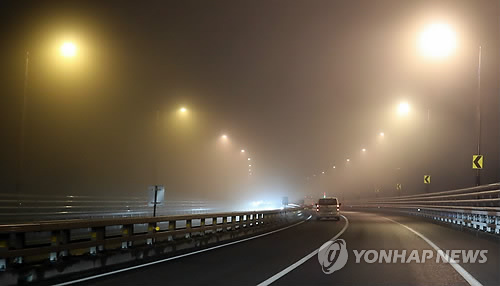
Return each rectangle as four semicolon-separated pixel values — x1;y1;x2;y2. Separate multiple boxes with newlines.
54;215;312;286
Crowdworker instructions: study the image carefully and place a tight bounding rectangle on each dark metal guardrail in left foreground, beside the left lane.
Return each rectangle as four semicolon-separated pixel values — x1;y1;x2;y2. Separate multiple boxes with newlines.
0;208;305;284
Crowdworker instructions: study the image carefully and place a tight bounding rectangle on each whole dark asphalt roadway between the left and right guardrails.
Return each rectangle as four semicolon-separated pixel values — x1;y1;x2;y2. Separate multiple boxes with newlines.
71;212;500;285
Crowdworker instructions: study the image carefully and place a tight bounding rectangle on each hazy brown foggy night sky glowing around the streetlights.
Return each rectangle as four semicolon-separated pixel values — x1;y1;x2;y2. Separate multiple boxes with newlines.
0;0;500;202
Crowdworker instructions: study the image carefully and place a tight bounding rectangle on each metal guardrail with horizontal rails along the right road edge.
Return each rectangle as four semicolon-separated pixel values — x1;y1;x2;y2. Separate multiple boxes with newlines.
346;183;500;235
